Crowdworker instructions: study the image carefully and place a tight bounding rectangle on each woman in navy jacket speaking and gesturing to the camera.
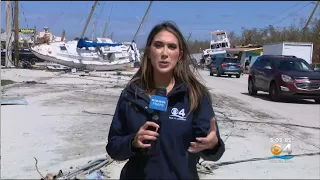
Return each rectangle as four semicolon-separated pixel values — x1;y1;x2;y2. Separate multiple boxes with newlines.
106;22;225;179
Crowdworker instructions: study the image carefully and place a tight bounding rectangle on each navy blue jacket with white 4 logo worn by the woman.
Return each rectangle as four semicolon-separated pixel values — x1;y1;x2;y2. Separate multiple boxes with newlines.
106;82;225;179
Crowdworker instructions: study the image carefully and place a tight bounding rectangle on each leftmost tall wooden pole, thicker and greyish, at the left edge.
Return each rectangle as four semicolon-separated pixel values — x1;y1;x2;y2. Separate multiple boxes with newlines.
5;1;14;67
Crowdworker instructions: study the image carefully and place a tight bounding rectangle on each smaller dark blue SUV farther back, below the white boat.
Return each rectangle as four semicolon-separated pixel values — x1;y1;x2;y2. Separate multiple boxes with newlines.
209;56;243;78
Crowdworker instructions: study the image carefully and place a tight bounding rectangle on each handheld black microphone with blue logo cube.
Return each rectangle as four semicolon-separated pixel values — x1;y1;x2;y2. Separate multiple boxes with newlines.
143;88;168;155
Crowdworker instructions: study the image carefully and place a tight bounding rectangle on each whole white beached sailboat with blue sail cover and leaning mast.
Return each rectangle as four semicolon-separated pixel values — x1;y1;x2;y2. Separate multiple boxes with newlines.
31;1;150;71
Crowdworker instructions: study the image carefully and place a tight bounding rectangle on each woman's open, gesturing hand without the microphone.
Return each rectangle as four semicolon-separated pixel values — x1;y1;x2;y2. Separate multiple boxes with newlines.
188;118;218;153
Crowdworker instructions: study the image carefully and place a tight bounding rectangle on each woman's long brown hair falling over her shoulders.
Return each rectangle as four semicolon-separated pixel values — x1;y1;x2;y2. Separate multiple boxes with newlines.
129;21;211;114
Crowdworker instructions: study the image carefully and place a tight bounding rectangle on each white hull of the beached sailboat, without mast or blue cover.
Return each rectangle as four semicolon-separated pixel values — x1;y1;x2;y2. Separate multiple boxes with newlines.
31;41;138;71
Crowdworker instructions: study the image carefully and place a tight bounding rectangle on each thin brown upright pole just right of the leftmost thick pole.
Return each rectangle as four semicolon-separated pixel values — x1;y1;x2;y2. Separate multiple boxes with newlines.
14;1;19;67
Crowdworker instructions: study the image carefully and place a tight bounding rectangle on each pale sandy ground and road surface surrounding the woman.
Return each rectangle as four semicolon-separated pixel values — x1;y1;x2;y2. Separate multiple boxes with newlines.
1;69;320;179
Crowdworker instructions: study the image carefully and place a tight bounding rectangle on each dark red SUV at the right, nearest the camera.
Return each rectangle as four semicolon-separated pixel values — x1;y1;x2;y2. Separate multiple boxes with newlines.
248;55;320;103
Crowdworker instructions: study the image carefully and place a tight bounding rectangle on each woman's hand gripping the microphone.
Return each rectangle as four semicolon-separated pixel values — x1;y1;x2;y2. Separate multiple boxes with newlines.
132;121;159;148
